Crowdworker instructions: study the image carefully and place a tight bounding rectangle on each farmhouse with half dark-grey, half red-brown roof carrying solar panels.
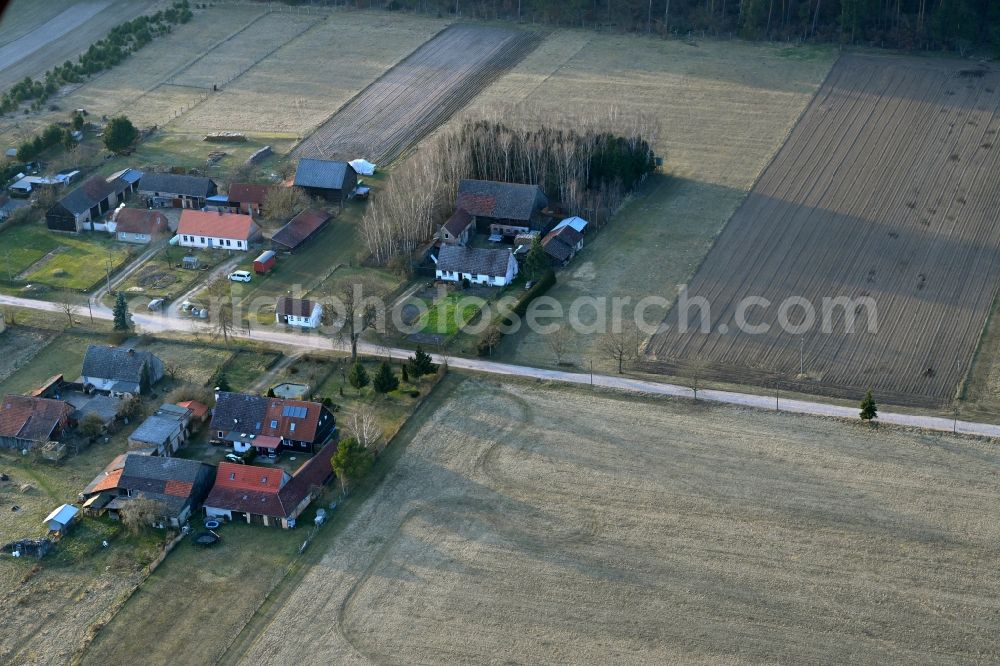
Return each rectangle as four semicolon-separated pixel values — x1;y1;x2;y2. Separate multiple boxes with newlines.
211;391;336;458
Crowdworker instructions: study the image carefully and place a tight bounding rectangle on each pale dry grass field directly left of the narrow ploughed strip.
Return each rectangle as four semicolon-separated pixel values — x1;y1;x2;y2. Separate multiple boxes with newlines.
171;11;448;137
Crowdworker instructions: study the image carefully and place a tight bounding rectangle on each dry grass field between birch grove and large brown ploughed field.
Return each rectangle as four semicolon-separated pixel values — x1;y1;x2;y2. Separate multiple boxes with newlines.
472;31;836;370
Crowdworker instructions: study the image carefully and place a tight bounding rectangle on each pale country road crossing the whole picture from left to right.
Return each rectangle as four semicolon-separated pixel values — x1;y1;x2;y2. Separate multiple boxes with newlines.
0;295;1000;437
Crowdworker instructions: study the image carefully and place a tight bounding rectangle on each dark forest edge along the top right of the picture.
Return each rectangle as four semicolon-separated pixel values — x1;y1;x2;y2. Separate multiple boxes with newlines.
300;0;1000;53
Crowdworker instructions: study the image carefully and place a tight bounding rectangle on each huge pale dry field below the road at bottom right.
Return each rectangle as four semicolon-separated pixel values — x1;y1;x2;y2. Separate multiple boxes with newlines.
236;377;1000;664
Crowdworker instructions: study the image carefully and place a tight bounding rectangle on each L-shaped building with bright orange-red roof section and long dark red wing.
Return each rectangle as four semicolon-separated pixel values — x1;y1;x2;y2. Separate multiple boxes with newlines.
205;441;337;529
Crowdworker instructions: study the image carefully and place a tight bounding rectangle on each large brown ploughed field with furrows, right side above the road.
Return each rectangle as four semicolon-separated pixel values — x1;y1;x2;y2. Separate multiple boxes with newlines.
647;56;1000;404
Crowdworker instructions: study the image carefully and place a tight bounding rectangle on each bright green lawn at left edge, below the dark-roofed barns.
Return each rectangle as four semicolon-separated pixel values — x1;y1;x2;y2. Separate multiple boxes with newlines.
0;223;137;291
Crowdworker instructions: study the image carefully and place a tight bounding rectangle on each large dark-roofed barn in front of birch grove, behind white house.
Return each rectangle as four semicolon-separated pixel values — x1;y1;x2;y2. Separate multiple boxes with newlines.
455;179;549;239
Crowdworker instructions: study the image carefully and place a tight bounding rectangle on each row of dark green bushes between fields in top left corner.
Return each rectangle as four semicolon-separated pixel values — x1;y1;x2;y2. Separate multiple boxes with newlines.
0;0;192;113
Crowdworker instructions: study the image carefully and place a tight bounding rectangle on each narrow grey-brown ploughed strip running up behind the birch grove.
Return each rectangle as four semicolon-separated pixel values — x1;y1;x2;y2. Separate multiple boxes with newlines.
295;25;538;164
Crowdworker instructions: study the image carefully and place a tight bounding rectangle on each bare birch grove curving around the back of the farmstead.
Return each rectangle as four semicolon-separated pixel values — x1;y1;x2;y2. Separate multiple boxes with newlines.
362;106;658;264
